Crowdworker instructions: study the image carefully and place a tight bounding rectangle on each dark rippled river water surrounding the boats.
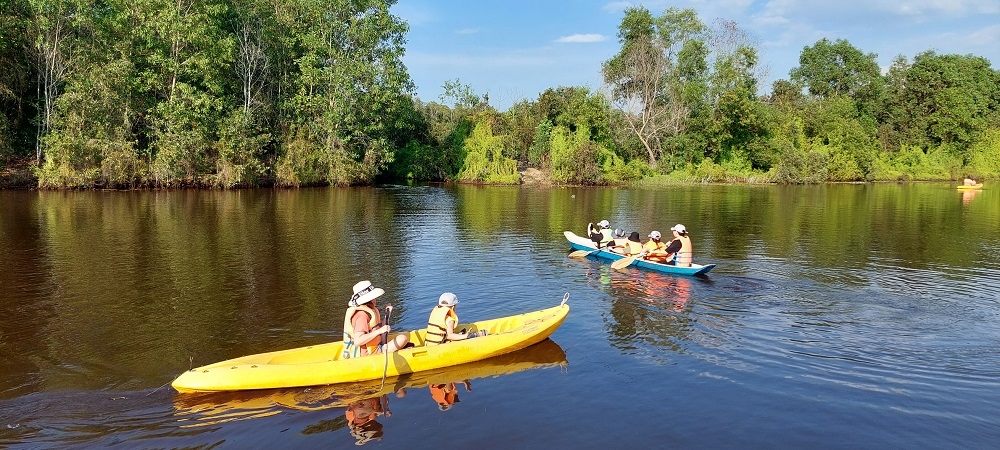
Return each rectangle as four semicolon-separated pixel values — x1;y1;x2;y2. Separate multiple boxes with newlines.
0;184;1000;448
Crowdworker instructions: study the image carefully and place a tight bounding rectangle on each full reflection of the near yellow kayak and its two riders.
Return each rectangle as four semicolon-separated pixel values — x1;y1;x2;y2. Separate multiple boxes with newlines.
174;339;568;434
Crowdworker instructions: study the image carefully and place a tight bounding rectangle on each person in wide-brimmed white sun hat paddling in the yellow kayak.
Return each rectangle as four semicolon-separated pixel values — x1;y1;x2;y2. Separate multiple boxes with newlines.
343;280;410;358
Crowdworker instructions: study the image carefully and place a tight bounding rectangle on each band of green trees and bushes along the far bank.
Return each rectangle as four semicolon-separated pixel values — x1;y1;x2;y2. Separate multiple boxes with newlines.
0;0;1000;189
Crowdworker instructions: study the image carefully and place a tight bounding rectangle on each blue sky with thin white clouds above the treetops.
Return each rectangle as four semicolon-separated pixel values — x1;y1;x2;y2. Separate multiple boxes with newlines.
392;0;1000;111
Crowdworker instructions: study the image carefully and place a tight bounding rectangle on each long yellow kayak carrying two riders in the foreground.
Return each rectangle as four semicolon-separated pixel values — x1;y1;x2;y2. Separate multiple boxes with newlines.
171;294;569;393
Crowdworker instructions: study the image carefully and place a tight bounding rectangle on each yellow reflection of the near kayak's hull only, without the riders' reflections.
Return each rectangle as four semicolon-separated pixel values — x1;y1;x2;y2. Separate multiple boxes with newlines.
174;339;569;427
